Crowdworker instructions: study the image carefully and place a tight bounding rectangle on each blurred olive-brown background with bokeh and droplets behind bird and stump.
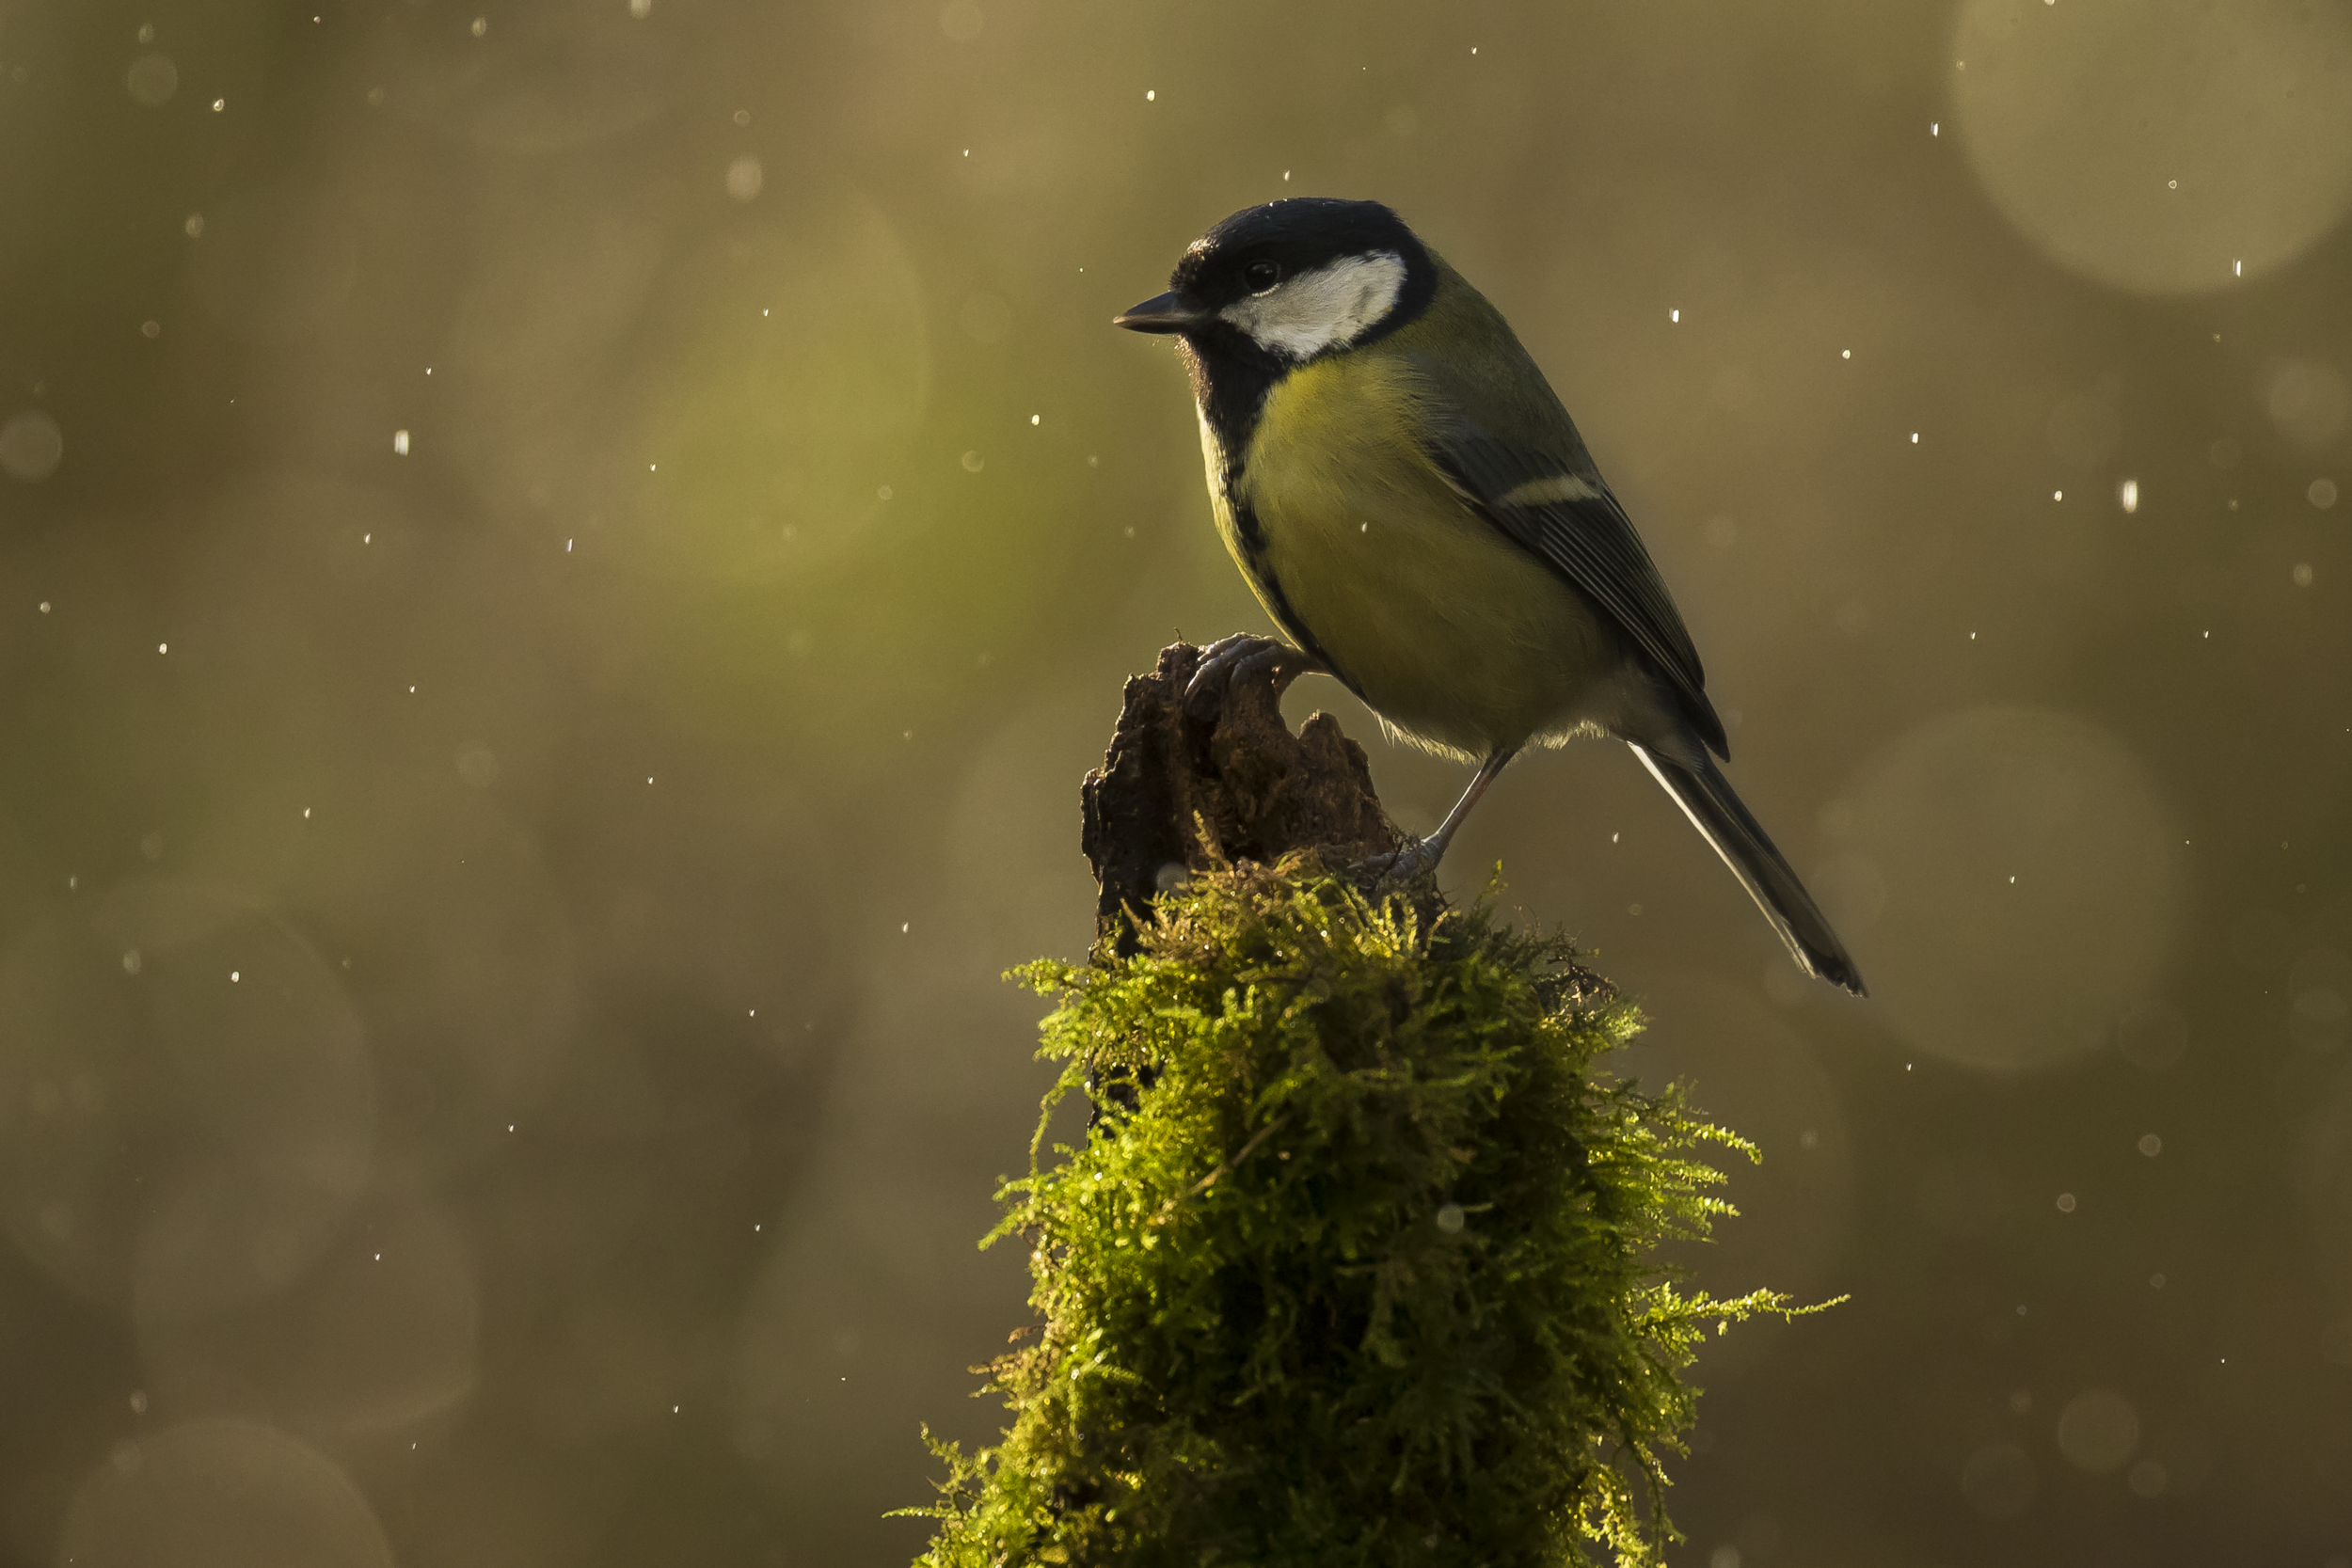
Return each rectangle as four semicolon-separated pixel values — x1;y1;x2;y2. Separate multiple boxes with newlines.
0;0;2352;1568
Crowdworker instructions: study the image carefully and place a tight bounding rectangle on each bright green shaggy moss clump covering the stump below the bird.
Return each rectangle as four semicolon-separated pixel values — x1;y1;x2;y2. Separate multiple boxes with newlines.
915;863;1788;1568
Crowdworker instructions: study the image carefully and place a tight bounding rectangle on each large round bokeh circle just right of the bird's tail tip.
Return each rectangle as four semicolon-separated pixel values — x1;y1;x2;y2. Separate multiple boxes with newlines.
1825;707;2185;1069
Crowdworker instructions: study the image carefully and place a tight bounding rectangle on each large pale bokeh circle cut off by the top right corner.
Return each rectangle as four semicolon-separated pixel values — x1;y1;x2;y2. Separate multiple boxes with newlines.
1947;0;2352;293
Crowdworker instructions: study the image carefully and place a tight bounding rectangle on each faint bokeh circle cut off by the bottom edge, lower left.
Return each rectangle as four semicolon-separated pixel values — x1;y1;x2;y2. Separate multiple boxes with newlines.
56;1420;393;1568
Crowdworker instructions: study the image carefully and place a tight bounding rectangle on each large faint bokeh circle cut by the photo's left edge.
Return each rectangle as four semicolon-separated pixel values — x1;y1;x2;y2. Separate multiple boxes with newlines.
0;881;376;1319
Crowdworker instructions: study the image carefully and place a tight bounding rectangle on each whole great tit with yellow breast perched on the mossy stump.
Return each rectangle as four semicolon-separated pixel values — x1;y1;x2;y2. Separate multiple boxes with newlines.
1115;198;1863;997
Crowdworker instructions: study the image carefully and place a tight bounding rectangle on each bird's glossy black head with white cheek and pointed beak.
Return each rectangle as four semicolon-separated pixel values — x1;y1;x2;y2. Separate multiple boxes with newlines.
1118;195;1438;373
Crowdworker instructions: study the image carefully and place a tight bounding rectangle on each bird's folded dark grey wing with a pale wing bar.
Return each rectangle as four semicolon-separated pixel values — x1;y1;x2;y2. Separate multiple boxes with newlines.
1425;406;1729;757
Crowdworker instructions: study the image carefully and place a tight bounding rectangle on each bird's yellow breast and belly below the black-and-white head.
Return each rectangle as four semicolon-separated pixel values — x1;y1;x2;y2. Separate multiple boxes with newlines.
1202;347;1623;757
